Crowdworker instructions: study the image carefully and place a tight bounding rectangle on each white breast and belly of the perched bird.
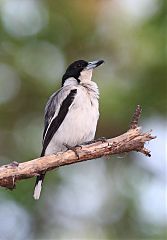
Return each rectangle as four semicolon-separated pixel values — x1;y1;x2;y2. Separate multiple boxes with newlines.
45;82;99;155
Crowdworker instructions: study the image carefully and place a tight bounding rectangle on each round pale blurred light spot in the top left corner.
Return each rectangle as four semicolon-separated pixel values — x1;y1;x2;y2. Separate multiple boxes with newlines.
1;0;48;37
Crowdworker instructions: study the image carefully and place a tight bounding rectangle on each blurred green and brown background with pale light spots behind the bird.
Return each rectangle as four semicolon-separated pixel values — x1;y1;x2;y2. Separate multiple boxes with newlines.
0;0;167;240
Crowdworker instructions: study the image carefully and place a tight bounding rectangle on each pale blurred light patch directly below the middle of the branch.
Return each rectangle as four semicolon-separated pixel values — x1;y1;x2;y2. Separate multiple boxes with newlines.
55;161;107;217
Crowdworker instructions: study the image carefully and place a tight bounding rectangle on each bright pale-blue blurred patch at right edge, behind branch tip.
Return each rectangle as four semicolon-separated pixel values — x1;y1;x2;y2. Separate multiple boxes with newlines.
137;117;167;225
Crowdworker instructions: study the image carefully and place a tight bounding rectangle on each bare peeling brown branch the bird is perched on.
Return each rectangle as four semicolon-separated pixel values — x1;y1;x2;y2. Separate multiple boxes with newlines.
0;105;156;189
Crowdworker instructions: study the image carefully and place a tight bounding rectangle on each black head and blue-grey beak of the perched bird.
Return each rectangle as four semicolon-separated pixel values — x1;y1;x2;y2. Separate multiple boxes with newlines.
62;60;104;86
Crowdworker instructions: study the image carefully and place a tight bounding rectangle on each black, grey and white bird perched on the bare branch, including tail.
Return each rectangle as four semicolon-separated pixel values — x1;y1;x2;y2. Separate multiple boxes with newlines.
33;60;104;200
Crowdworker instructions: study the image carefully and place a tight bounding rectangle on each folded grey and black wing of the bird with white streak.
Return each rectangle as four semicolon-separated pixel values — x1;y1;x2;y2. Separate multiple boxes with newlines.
41;89;77;156
